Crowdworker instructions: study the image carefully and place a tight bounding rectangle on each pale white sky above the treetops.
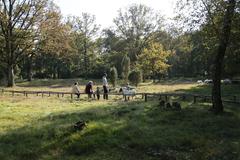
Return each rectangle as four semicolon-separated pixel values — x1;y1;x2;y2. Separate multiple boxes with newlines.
54;0;176;28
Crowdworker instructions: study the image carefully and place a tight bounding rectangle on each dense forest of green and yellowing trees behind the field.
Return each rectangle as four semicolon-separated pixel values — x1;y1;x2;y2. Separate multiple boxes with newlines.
0;0;240;86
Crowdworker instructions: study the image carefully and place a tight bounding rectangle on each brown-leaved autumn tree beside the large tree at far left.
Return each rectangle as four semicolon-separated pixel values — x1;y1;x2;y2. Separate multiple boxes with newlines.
36;5;73;78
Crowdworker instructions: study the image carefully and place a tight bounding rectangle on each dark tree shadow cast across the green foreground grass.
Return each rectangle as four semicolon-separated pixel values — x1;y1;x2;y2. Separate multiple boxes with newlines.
0;102;240;160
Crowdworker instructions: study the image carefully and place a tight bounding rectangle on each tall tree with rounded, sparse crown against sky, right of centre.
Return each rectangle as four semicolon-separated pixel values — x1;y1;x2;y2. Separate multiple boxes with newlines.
114;4;163;63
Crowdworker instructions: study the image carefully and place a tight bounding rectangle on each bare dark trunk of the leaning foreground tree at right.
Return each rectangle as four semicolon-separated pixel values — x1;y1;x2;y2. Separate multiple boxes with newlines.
211;0;236;113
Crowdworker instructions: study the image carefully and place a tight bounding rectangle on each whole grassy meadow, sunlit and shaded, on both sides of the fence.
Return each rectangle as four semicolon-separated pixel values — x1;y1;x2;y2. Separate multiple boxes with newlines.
0;80;240;160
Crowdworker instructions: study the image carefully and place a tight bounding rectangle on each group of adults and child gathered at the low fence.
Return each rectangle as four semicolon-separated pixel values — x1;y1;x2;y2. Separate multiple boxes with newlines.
72;73;109;100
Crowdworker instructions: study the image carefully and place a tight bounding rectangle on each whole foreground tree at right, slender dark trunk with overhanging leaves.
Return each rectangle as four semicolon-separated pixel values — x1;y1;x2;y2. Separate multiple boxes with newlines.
175;0;239;113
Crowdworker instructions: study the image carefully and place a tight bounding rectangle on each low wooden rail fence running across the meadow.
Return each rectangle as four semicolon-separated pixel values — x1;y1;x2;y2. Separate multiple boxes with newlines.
1;89;240;104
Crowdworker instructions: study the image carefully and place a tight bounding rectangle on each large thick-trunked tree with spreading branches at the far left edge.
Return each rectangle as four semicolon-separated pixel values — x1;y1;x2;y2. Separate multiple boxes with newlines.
0;0;46;86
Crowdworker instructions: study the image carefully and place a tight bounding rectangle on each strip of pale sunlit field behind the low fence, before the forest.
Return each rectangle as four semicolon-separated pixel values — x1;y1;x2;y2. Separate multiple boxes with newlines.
2;79;240;97
